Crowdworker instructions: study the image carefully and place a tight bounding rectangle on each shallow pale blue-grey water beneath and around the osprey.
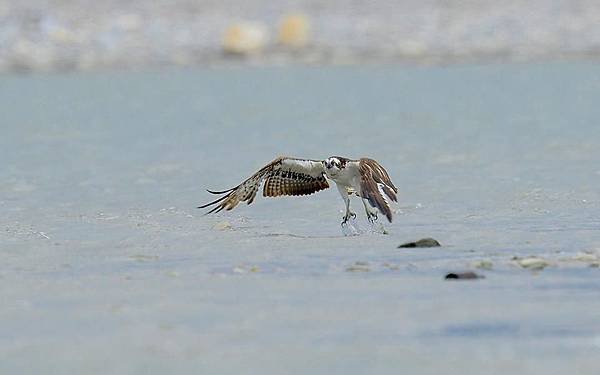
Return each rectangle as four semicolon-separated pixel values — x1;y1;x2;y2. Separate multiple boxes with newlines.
0;63;600;374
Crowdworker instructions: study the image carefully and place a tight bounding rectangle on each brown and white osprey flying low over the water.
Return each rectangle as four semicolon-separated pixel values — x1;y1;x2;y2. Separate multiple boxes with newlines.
198;156;398;226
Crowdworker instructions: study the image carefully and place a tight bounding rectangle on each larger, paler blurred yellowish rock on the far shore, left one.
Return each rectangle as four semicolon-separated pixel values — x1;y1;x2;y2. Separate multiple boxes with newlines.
223;22;268;55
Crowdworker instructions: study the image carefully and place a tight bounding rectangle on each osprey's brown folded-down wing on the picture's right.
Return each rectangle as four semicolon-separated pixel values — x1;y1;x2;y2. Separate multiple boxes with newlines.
358;158;398;223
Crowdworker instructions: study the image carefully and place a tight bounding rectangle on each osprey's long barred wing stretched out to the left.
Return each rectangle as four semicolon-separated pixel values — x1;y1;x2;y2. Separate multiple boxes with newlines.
198;156;329;214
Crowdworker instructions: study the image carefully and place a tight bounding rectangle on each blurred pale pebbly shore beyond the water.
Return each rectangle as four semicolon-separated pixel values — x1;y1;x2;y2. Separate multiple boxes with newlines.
0;0;600;72
